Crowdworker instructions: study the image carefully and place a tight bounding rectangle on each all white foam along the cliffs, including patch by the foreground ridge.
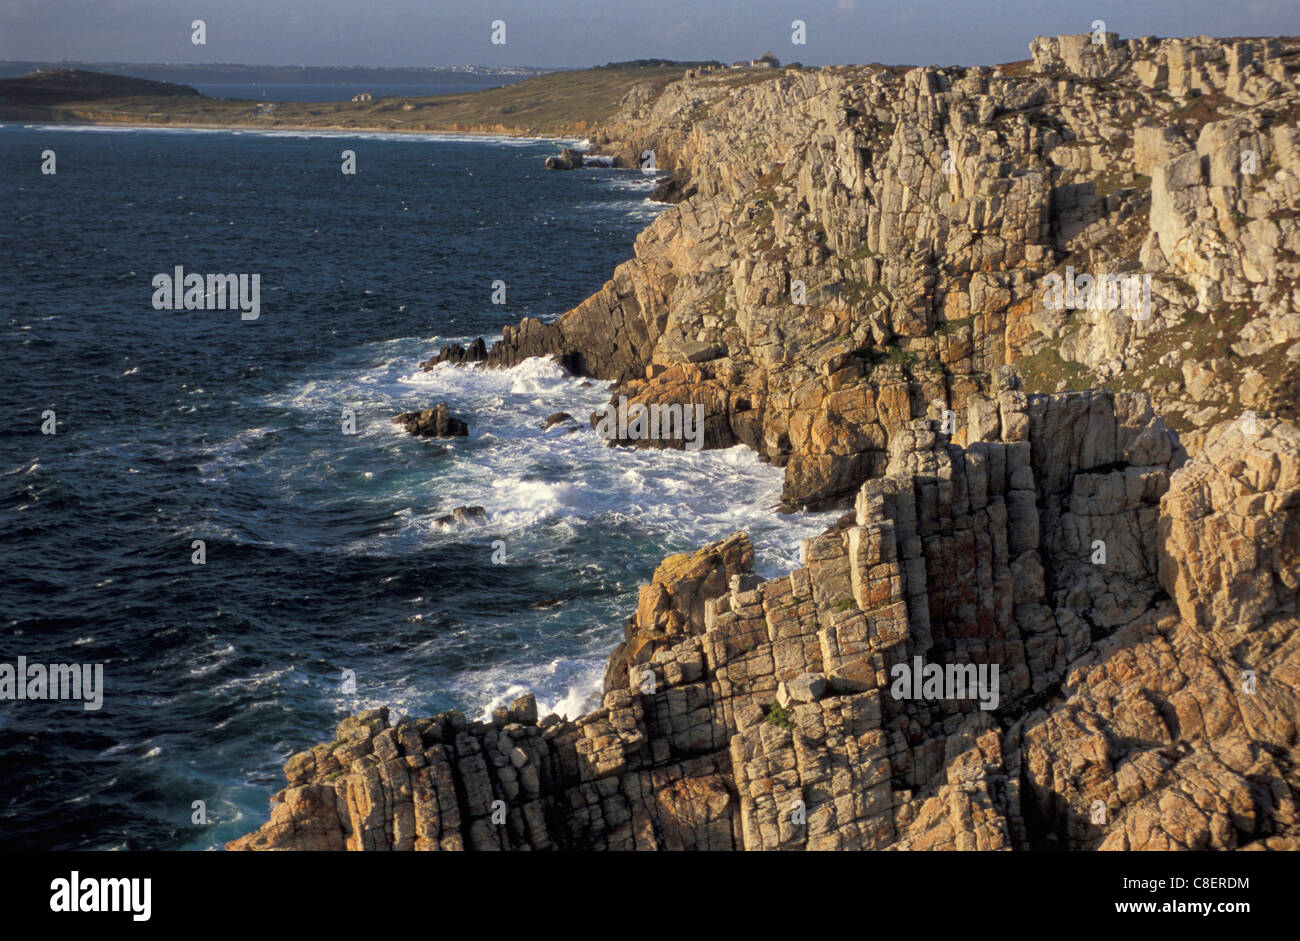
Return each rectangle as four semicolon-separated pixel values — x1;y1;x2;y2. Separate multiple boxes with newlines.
219;338;836;717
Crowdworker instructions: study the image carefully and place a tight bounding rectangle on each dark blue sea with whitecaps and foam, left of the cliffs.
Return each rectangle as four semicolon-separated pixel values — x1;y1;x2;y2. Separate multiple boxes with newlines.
0;125;828;849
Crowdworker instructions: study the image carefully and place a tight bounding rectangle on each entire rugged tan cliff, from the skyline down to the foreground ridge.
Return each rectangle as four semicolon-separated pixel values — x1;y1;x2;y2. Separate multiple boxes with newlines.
230;34;1300;849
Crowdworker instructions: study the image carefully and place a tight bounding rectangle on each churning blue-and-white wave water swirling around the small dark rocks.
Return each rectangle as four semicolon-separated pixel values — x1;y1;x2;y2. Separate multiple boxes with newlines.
199;341;835;572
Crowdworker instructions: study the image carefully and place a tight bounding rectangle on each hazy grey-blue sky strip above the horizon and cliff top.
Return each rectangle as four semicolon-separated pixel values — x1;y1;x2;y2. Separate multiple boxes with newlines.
0;0;1300;68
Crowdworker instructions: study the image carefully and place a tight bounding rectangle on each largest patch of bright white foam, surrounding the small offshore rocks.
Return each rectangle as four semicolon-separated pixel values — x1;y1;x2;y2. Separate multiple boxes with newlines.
254;342;833;558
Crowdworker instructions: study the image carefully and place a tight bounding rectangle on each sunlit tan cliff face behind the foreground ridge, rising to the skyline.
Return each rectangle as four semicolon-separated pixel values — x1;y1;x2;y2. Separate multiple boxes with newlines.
430;34;1300;507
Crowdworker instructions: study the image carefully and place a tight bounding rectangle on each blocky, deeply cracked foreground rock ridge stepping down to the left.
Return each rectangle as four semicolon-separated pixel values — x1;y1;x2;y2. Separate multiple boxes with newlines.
230;390;1300;850
